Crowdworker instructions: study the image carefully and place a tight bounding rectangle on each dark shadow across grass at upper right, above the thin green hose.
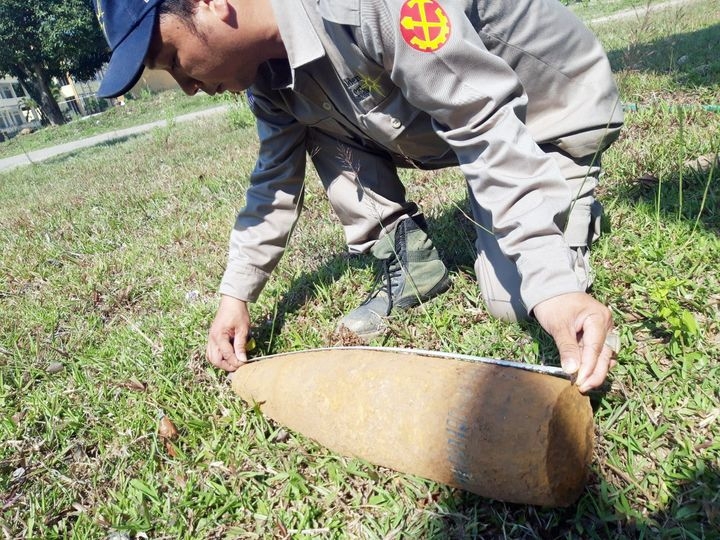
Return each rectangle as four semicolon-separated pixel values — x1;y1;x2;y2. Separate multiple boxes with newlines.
608;24;720;88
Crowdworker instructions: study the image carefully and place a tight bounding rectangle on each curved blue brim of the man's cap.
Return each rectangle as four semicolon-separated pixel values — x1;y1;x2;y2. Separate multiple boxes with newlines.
97;9;157;98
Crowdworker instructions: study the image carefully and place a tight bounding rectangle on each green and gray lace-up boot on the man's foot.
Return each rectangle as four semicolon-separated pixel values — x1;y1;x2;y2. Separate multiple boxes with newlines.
339;214;450;340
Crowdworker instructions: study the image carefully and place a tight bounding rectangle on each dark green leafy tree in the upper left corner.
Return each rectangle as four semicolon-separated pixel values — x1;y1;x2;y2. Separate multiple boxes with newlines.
0;0;109;124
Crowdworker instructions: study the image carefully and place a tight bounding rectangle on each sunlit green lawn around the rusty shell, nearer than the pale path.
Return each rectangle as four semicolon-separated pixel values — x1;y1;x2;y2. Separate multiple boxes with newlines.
0;3;720;539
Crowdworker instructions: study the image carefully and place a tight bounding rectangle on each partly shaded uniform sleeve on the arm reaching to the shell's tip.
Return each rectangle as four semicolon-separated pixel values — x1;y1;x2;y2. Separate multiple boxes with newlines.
220;95;306;302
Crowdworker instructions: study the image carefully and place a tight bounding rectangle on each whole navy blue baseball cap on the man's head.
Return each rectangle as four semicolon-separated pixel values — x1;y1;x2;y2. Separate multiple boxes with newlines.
95;0;163;97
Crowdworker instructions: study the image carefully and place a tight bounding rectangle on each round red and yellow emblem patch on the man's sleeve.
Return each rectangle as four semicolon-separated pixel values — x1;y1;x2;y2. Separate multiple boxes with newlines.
400;0;450;52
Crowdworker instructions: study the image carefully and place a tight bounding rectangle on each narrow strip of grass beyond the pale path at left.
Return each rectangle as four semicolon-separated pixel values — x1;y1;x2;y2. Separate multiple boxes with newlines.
0;90;221;159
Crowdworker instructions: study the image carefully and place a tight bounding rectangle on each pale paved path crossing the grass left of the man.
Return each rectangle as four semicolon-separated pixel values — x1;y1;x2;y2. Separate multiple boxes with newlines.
0;105;228;172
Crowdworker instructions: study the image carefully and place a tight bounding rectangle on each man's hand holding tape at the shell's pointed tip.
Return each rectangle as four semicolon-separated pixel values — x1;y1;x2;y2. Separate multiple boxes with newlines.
206;296;250;371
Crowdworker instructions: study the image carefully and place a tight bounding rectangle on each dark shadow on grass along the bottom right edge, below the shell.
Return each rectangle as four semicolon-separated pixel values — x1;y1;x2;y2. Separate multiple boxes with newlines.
428;459;720;540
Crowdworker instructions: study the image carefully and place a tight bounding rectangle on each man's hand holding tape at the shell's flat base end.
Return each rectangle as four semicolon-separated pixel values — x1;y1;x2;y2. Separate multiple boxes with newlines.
533;292;615;392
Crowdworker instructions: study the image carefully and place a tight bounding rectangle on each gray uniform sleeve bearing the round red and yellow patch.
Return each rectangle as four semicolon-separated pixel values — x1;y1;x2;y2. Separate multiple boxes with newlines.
359;0;582;310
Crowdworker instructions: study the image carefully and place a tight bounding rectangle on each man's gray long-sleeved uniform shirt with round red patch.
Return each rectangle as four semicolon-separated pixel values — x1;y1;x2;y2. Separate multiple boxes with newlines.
220;0;621;310
